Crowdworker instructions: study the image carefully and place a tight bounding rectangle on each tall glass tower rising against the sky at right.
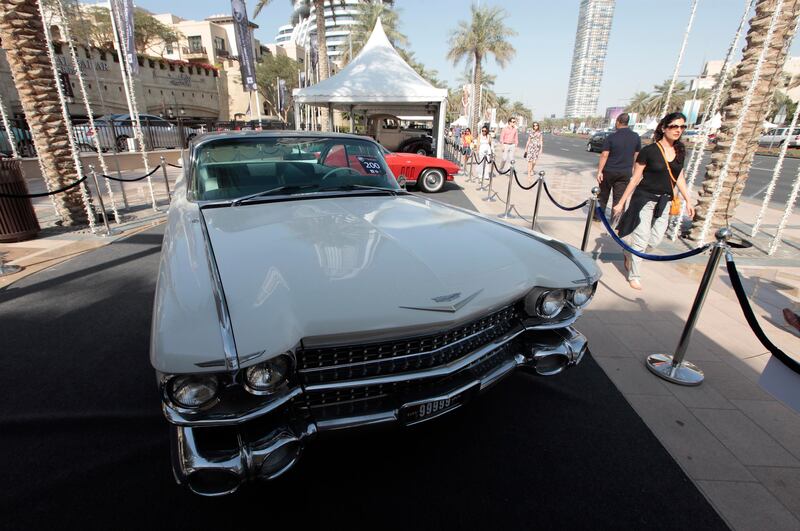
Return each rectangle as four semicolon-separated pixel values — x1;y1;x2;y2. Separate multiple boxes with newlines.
564;0;615;118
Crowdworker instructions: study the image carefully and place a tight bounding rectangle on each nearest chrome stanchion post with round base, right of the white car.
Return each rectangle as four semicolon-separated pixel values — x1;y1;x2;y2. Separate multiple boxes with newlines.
645;227;732;385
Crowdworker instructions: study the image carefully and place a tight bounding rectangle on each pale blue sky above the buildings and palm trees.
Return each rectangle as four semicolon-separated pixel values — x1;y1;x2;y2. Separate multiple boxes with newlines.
135;0;800;119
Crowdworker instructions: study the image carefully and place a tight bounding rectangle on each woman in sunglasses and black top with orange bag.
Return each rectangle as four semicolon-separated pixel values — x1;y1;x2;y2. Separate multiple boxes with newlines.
612;112;694;290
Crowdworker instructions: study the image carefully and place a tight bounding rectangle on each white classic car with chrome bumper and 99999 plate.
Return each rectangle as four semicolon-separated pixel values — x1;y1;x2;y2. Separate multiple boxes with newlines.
150;131;600;496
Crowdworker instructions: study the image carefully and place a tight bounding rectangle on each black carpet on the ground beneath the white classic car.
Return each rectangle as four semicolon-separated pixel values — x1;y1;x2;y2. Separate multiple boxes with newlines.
0;218;725;529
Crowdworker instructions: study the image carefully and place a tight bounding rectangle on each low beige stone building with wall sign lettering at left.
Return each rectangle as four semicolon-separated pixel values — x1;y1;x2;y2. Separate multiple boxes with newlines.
0;43;222;120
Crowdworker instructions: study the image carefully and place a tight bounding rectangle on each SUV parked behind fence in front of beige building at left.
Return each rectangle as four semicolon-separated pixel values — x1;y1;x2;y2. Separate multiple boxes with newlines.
73;114;201;151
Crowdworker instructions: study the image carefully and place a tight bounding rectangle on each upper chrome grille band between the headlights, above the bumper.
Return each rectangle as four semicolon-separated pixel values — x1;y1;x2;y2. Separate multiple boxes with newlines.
297;306;517;386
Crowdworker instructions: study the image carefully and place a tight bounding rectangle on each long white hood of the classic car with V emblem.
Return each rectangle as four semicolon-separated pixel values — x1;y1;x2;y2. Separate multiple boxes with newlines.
202;196;597;364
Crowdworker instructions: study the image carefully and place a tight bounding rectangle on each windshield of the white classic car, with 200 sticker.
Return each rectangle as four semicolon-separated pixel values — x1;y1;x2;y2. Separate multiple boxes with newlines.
192;137;400;200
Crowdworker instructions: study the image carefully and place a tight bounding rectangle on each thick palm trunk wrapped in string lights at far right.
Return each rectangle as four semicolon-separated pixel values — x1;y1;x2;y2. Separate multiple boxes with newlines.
692;0;800;239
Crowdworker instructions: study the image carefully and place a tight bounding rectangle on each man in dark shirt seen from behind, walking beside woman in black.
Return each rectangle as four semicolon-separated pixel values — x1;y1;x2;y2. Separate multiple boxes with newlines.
595;112;642;221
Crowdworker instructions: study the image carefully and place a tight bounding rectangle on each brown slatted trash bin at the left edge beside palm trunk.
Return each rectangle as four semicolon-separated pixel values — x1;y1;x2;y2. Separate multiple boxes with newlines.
0;160;41;242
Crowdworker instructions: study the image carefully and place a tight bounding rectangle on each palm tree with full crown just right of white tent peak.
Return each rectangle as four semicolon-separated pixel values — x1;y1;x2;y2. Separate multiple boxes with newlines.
447;4;517;133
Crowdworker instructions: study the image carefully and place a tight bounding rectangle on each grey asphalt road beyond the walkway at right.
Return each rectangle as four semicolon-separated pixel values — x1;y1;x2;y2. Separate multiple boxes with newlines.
544;135;800;208
